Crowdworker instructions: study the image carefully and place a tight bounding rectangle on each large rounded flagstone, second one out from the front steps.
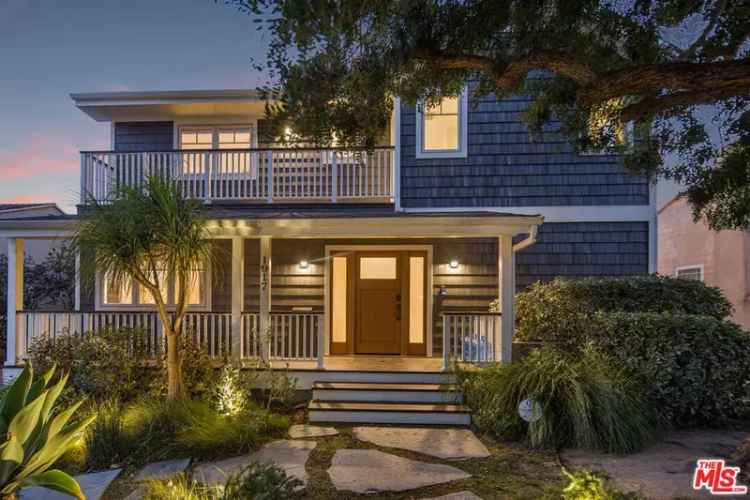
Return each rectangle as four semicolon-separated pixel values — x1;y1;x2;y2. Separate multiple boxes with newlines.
328;450;471;493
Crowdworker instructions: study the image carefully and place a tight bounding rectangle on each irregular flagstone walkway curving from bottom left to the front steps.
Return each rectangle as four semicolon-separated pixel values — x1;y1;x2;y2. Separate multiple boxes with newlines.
110;425;490;500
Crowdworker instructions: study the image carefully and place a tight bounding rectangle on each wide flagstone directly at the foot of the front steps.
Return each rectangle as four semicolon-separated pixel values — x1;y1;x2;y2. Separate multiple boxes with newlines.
354;427;490;459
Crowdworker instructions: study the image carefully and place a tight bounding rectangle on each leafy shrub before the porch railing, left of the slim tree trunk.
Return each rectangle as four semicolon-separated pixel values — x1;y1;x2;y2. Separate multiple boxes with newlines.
29;328;154;401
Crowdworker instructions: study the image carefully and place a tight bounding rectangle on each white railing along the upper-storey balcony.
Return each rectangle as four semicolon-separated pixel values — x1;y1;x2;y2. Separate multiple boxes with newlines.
81;147;394;204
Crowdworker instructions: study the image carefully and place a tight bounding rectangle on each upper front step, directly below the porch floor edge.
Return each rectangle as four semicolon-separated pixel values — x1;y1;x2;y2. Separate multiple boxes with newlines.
313;382;463;404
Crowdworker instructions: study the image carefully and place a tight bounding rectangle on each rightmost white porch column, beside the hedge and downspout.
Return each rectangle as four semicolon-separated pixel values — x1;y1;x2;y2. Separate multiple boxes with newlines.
495;235;516;363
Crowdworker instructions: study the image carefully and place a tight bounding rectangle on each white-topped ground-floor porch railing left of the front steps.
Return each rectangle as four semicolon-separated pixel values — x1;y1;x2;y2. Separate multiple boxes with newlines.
16;311;323;360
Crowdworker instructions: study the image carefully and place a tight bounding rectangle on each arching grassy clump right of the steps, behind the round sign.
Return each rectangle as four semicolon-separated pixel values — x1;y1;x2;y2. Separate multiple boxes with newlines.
461;347;656;453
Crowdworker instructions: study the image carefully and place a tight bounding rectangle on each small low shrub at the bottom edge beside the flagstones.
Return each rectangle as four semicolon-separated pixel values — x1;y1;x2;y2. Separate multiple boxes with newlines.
223;462;302;500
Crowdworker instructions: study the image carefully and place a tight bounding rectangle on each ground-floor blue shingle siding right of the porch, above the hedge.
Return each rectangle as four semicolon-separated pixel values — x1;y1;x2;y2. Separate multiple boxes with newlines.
516;222;648;290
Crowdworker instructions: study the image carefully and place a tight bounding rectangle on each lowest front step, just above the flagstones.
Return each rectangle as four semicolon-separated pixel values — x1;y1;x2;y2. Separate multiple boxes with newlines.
308;401;471;425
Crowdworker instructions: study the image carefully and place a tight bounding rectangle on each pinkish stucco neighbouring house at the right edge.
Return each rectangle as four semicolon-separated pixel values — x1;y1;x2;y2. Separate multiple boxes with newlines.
658;196;750;330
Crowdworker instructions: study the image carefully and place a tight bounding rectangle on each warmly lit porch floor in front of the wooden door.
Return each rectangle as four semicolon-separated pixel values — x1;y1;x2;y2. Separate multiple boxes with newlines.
271;355;443;372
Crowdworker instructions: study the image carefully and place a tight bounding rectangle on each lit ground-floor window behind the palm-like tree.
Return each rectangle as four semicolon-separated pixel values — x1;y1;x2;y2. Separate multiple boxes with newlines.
96;266;211;310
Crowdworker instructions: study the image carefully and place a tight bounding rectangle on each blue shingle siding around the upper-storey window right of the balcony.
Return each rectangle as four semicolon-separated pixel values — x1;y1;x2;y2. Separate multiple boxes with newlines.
401;95;649;208
